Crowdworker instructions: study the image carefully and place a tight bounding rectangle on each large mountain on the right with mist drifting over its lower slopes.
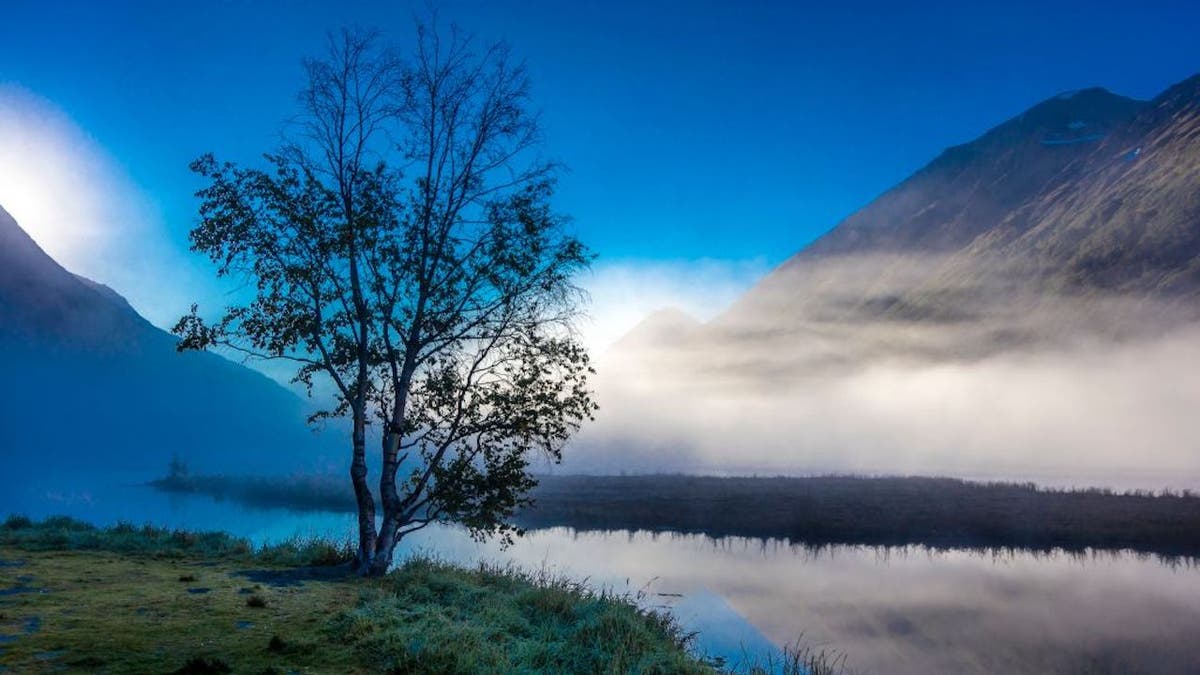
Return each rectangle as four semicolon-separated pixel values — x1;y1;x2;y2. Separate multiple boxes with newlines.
657;76;1200;368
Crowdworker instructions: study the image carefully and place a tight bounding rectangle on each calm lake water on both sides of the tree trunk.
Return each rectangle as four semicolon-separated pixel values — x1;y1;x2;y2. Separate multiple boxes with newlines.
0;475;1200;674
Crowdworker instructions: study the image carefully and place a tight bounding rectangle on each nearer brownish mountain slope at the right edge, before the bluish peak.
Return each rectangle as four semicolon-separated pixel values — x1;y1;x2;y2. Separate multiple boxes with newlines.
968;76;1200;295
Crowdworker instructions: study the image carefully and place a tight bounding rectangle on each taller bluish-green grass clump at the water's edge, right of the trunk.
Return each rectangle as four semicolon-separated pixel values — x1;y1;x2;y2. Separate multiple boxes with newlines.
330;557;714;674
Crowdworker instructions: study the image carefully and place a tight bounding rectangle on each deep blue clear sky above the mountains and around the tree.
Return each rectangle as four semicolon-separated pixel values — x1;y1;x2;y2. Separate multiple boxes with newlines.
0;0;1200;343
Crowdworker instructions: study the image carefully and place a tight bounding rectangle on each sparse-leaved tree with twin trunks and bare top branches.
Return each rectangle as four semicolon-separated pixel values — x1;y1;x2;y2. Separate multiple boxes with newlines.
175;26;595;574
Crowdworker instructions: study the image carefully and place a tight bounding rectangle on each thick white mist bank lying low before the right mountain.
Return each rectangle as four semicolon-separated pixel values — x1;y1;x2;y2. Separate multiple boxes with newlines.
559;257;1200;489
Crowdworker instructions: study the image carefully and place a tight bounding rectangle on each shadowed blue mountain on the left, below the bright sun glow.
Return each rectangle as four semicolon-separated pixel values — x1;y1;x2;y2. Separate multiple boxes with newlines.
0;201;341;490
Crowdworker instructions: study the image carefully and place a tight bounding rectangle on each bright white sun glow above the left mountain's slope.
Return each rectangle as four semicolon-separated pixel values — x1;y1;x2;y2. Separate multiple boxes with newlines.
0;83;211;327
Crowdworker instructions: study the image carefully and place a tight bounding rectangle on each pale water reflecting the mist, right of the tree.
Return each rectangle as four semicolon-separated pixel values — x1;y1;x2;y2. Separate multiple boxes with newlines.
451;530;1200;674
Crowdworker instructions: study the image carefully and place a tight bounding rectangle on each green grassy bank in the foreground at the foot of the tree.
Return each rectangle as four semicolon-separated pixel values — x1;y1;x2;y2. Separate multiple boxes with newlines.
0;516;844;675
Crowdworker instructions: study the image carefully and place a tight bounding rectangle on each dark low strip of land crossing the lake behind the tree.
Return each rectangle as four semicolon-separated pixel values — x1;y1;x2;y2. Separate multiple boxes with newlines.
152;474;1200;558
